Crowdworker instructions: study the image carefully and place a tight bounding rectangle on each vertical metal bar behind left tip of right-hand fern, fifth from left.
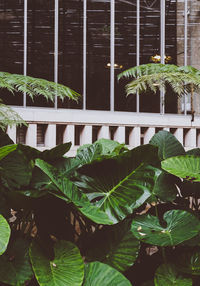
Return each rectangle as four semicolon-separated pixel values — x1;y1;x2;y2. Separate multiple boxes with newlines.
136;0;140;112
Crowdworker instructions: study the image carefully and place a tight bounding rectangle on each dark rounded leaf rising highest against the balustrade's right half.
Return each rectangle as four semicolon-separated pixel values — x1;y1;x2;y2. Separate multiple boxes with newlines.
149;130;185;160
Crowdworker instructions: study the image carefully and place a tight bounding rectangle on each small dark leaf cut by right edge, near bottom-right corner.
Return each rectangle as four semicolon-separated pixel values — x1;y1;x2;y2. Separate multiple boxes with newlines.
175;251;200;275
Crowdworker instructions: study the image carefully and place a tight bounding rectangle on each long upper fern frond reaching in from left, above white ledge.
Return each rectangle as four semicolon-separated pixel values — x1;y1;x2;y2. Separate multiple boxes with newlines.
0;72;80;101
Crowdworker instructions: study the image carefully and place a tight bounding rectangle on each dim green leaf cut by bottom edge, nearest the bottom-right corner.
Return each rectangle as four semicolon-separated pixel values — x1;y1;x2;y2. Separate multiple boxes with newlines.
154;264;192;286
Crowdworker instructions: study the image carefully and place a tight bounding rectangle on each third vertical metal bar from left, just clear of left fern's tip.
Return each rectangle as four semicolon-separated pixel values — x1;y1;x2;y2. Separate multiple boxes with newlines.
83;0;87;110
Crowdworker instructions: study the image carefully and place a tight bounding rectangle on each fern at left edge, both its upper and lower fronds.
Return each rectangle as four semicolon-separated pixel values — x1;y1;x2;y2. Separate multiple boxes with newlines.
0;72;79;130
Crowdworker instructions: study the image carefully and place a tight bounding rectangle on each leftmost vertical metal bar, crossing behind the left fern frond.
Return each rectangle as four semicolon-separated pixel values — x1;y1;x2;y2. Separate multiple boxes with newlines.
23;0;28;107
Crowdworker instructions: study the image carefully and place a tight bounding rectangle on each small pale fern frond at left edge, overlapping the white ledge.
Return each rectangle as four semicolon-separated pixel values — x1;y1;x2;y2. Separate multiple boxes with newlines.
0;103;27;130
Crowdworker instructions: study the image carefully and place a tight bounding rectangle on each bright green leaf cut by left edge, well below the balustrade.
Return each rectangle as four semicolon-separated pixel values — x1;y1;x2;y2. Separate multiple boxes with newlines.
0;215;10;255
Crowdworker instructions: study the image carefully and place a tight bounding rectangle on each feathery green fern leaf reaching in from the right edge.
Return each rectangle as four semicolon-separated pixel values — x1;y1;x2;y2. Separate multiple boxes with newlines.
118;64;200;96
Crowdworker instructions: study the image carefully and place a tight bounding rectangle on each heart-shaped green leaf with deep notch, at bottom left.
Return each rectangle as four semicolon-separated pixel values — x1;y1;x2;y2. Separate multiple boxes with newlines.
30;241;84;286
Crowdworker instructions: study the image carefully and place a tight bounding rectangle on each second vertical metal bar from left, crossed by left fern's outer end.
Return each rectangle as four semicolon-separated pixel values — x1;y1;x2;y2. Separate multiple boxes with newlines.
54;0;59;109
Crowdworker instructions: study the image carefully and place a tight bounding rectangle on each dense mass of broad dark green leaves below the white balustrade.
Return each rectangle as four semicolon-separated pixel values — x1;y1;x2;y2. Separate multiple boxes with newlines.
0;131;200;286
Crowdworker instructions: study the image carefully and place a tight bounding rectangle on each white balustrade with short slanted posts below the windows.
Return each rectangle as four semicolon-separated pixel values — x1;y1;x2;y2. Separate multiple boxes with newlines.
7;107;200;155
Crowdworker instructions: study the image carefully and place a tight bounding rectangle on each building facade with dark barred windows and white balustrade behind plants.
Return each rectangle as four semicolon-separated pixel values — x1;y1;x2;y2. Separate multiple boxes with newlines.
0;0;200;155
